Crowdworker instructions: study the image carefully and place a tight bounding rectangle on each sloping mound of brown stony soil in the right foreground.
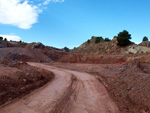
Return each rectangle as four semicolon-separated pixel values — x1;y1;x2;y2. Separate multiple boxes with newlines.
99;61;150;113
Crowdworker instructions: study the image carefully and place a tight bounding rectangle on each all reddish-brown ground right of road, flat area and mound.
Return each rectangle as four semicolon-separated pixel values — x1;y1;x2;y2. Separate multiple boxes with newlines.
47;60;150;113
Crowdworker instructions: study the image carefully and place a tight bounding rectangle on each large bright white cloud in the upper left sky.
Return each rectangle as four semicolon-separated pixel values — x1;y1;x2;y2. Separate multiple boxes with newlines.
0;0;64;29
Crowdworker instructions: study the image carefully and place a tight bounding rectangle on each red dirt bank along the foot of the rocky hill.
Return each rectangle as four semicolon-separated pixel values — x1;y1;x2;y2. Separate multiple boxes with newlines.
58;54;126;64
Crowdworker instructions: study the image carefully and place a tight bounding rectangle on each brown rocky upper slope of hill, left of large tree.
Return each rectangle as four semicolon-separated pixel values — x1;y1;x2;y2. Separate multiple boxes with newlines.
72;37;124;55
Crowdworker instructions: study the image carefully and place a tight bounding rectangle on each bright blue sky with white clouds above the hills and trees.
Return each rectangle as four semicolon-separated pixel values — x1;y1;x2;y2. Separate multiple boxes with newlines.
0;0;150;48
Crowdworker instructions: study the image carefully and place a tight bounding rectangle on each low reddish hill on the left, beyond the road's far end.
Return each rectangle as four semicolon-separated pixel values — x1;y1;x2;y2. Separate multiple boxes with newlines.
0;40;67;62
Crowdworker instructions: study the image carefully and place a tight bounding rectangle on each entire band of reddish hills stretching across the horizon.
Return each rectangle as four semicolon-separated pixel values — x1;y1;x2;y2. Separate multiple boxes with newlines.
0;37;150;64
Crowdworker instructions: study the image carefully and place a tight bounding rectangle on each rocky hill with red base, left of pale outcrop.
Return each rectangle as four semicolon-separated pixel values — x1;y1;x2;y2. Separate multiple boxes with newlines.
58;37;127;64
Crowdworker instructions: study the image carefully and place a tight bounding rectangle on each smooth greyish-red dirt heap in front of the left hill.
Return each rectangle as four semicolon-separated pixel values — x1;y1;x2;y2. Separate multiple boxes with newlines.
0;47;51;62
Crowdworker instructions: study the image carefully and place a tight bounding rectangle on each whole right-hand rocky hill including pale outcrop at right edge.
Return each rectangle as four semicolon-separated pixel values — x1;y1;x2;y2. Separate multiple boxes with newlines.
58;37;150;64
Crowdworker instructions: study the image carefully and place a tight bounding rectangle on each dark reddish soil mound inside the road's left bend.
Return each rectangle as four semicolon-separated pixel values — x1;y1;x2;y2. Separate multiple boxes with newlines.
0;61;54;105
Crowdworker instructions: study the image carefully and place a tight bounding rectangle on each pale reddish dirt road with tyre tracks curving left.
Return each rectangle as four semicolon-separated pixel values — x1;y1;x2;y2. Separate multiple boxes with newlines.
0;63;119;113
